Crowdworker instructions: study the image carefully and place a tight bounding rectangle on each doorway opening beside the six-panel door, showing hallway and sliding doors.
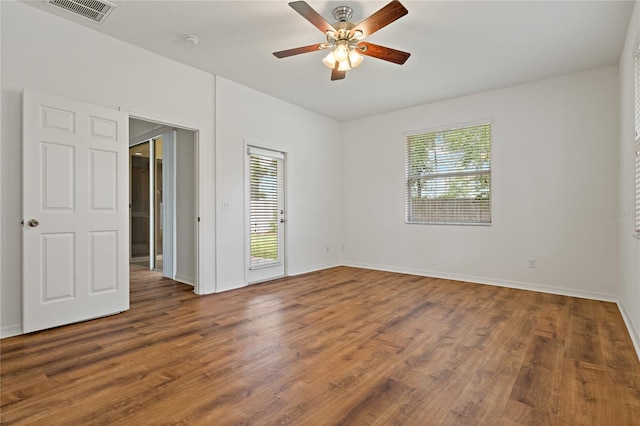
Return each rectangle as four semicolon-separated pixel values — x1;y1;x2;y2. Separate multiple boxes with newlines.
129;118;197;287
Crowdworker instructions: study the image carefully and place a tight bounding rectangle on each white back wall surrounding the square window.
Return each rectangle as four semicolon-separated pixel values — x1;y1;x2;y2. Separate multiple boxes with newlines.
342;67;619;300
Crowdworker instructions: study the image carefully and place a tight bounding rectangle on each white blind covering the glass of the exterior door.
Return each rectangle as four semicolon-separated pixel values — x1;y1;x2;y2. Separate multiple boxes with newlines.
249;148;284;268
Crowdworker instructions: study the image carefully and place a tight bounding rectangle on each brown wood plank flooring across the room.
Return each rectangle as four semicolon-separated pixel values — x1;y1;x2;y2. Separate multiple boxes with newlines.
0;266;640;425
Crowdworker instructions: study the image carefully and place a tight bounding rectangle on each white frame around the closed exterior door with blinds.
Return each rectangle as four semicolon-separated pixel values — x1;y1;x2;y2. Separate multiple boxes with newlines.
243;139;291;285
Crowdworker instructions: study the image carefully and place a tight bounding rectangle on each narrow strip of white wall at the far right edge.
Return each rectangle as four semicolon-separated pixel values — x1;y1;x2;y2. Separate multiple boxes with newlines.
617;2;640;356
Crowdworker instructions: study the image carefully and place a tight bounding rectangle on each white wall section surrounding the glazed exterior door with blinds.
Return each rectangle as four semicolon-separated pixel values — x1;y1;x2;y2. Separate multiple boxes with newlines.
216;77;341;291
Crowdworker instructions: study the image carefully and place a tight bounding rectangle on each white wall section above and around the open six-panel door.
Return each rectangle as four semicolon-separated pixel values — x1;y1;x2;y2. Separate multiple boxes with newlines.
0;2;215;335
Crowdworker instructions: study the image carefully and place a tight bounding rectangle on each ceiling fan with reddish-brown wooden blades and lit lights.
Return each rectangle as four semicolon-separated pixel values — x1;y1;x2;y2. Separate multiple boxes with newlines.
273;0;411;80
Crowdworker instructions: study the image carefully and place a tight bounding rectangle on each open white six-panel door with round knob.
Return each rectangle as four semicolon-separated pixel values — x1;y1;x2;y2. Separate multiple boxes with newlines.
23;90;129;333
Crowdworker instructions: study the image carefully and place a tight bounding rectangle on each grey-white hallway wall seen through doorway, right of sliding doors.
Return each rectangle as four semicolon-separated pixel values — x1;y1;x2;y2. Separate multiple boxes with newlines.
176;129;198;285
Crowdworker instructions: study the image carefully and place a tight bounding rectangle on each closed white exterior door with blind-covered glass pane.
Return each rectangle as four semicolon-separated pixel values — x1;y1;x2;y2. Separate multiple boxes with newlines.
245;146;285;284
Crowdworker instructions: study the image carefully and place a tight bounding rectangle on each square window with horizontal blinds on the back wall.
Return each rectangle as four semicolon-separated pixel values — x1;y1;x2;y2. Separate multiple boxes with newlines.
405;122;491;225
